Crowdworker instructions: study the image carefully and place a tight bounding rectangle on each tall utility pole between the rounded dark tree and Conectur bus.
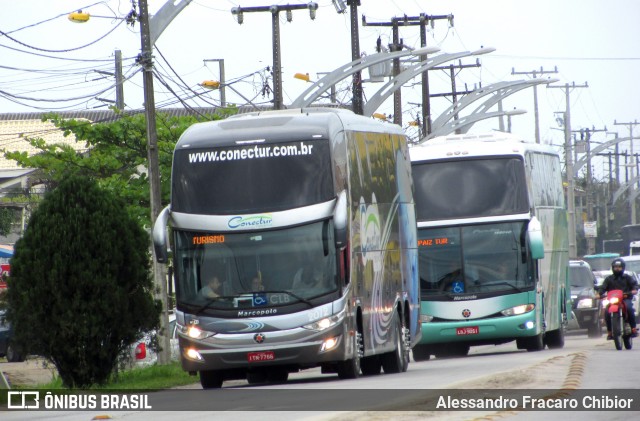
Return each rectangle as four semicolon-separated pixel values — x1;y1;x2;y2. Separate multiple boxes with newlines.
138;0;171;364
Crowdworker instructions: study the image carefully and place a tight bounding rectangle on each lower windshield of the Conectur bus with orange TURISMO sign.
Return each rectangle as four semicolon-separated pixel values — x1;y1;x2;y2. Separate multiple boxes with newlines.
174;220;338;309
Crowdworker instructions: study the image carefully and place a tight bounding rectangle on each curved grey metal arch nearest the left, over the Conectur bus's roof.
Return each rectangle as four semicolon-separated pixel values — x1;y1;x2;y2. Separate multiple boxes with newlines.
289;47;440;108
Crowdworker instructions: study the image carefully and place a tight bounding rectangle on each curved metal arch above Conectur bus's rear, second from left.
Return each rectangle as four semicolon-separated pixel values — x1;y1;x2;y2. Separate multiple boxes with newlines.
363;49;494;116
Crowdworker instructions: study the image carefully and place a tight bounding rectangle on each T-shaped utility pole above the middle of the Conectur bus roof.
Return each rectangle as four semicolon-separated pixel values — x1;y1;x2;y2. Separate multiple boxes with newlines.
231;2;318;110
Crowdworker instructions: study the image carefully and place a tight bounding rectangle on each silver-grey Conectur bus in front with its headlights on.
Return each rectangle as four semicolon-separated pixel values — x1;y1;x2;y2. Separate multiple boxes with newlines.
154;109;421;388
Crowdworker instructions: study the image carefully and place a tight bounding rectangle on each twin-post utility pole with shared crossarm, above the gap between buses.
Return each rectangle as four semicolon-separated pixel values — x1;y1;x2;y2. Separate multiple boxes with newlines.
362;13;453;128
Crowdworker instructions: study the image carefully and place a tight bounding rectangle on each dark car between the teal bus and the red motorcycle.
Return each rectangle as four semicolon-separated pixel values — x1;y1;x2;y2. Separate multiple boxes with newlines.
569;260;602;338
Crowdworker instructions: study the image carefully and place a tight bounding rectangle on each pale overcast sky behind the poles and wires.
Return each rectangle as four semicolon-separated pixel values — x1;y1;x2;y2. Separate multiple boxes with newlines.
0;0;640;176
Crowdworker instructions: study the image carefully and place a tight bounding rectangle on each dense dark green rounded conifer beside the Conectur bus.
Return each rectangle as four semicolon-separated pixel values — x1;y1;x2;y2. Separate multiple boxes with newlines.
7;173;160;387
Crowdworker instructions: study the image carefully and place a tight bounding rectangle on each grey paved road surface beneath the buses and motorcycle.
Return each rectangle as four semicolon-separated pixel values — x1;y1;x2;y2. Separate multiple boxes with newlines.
2;332;640;421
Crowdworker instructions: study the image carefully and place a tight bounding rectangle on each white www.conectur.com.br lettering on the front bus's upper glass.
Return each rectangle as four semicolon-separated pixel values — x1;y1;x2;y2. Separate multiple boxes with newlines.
189;142;313;163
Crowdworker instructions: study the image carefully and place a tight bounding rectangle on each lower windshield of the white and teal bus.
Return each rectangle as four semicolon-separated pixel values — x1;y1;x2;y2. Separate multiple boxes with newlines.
418;222;534;299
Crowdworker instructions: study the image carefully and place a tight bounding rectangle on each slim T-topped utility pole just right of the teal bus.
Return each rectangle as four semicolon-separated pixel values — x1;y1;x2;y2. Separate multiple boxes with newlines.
547;82;589;258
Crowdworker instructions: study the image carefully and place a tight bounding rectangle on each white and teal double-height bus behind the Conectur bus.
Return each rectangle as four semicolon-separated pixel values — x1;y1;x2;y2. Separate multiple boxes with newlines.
410;133;571;361
